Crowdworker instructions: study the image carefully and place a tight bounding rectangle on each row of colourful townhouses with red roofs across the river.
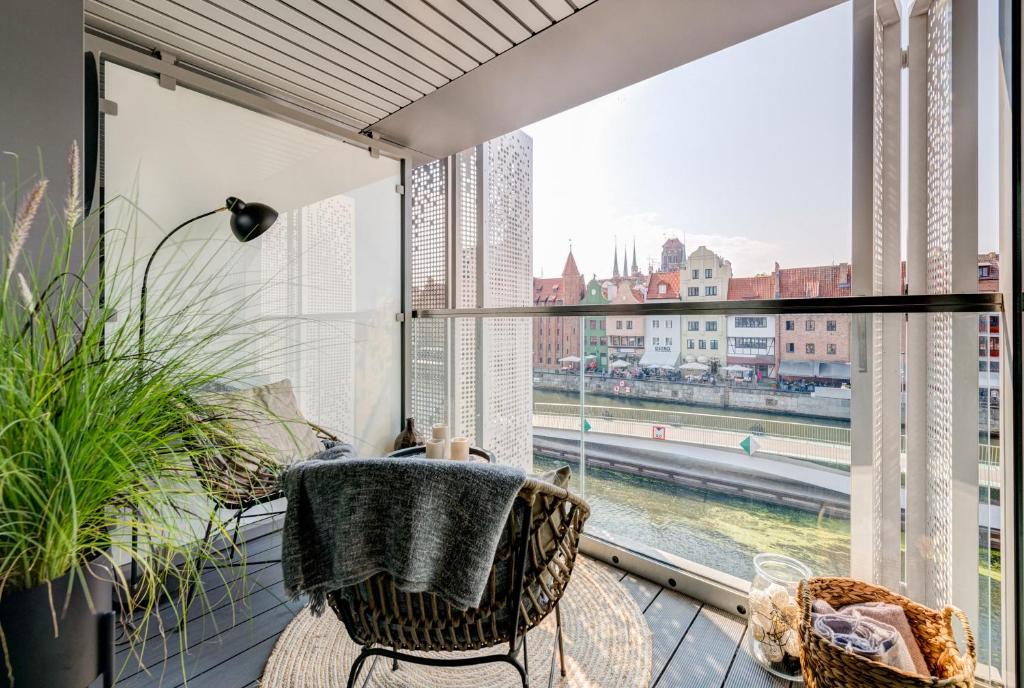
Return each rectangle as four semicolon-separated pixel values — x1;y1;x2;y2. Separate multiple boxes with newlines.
534;239;999;385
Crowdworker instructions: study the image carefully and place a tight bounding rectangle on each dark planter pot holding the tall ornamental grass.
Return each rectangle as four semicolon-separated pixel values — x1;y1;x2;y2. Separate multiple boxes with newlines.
0;564;114;688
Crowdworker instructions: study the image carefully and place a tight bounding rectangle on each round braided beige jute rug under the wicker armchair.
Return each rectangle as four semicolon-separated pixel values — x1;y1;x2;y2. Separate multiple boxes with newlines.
260;557;651;688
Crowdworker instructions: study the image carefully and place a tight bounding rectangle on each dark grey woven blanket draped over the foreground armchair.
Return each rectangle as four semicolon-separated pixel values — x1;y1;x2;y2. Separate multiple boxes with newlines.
282;450;526;614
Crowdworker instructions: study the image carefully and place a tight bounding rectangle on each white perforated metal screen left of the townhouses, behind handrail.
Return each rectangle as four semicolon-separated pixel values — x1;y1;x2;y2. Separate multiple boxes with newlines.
412;132;534;468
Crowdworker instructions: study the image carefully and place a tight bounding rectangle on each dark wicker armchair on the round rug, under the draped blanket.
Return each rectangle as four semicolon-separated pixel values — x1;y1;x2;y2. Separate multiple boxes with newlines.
328;478;590;688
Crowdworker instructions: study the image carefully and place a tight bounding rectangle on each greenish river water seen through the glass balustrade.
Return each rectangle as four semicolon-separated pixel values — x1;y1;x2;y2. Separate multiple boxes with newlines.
534;390;1001;667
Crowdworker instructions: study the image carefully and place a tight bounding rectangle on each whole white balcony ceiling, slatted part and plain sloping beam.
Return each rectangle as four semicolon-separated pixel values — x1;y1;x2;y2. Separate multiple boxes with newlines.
85;0;840;157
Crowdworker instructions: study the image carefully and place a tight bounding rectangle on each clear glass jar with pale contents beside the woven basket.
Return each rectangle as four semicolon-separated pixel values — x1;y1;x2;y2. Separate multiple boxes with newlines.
746;554;811;683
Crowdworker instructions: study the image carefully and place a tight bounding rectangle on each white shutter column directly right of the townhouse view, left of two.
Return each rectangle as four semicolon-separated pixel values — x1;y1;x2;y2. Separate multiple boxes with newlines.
851;0;902;590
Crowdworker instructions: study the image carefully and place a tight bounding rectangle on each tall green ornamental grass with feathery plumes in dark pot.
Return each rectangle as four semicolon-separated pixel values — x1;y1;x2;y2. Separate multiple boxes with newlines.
0;149;264;688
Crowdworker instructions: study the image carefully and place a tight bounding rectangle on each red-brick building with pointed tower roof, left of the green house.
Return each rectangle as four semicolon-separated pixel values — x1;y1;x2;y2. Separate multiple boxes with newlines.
534;250;586;370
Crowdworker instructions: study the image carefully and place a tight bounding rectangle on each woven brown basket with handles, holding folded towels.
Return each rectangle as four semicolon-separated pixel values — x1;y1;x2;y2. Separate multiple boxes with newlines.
798;577;977;688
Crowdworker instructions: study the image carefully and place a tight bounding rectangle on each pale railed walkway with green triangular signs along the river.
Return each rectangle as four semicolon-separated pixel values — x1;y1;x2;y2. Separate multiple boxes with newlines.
534;401;999;482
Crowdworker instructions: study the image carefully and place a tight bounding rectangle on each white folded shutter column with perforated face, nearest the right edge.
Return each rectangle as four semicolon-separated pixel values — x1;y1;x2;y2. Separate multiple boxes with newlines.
907;0;978;625
